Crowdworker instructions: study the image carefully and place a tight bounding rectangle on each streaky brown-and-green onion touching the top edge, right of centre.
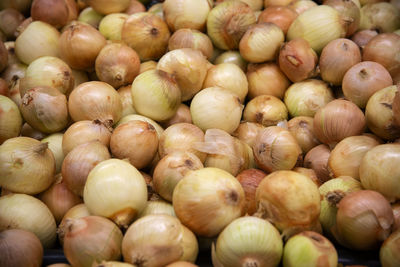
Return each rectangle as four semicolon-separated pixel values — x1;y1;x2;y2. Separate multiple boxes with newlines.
207;0;256;50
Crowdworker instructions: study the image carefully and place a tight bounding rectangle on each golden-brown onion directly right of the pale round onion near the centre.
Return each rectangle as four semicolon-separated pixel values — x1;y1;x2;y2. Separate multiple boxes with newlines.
243;95;288;127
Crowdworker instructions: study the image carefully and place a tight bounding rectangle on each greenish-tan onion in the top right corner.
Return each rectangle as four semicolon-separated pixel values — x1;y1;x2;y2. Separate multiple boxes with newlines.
360;2;400;32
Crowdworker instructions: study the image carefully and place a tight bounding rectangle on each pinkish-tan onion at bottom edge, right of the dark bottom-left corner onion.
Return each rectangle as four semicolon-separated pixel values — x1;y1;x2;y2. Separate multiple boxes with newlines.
60;216;123;267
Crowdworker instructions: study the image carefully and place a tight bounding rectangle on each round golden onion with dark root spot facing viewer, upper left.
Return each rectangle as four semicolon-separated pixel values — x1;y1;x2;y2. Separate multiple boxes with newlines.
121;12;171;61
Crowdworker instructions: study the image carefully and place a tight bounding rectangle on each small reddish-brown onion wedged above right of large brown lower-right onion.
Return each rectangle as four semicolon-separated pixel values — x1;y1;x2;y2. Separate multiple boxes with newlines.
303;144;331;183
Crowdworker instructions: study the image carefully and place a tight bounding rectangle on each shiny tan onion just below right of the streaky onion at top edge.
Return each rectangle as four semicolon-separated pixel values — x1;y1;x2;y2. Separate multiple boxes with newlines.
239;22;285;63
